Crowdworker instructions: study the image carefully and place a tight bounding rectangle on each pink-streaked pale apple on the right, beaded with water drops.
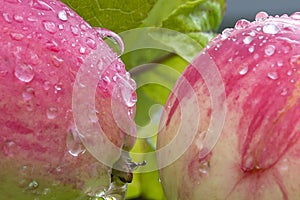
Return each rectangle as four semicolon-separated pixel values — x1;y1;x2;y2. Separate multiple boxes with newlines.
157;12;300;200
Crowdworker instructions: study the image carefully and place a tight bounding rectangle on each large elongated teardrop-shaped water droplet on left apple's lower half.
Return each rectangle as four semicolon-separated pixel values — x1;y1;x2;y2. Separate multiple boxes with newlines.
66;128;86;157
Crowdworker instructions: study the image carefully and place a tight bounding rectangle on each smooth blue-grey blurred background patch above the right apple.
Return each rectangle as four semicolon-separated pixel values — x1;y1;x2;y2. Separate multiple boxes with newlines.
219;0;300;31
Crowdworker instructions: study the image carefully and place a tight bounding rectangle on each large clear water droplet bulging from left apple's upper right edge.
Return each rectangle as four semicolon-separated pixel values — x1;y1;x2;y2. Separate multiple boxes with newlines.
95;28;124;56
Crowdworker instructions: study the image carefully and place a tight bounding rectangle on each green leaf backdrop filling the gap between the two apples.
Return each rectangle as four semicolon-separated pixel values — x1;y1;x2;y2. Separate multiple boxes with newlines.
62;0;225;200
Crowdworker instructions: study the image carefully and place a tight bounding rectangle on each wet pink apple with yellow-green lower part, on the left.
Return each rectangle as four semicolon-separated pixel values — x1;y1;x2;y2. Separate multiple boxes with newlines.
0;0;135;199
